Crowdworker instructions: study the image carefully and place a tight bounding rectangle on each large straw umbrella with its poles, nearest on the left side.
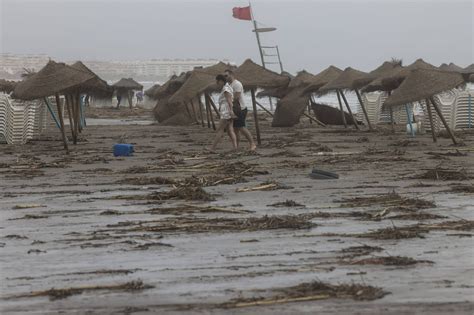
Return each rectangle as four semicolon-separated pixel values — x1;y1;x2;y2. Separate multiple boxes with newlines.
13;61;94;150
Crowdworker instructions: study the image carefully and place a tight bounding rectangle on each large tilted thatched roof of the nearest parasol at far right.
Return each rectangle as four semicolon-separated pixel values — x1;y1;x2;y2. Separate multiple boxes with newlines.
384;69;464;106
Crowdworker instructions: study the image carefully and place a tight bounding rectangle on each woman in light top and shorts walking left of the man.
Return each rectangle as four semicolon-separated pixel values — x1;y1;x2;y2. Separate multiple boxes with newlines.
210;74;237;151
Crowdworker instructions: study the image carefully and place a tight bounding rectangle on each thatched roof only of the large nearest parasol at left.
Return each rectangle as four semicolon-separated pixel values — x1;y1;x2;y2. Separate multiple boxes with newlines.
13;60;94;100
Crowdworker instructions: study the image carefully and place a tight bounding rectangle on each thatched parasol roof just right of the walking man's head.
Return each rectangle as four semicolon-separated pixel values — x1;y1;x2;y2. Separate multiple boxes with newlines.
234;59;290;90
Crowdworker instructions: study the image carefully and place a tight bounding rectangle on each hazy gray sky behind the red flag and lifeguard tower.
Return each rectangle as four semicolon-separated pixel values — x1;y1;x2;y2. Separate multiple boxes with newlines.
0;0;474;73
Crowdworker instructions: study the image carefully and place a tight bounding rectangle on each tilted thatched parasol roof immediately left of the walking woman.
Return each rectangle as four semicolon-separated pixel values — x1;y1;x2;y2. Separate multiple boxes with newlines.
169;70;215;103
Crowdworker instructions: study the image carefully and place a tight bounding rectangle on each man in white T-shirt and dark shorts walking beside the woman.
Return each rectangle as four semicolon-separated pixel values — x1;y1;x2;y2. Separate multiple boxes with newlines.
224;69;257;151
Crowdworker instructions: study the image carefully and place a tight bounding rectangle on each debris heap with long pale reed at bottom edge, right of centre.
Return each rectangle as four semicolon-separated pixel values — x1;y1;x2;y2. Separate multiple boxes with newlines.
223;281;389;308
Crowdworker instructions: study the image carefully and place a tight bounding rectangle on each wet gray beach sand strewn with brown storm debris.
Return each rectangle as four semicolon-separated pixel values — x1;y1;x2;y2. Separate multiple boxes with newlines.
0;109;474;314
